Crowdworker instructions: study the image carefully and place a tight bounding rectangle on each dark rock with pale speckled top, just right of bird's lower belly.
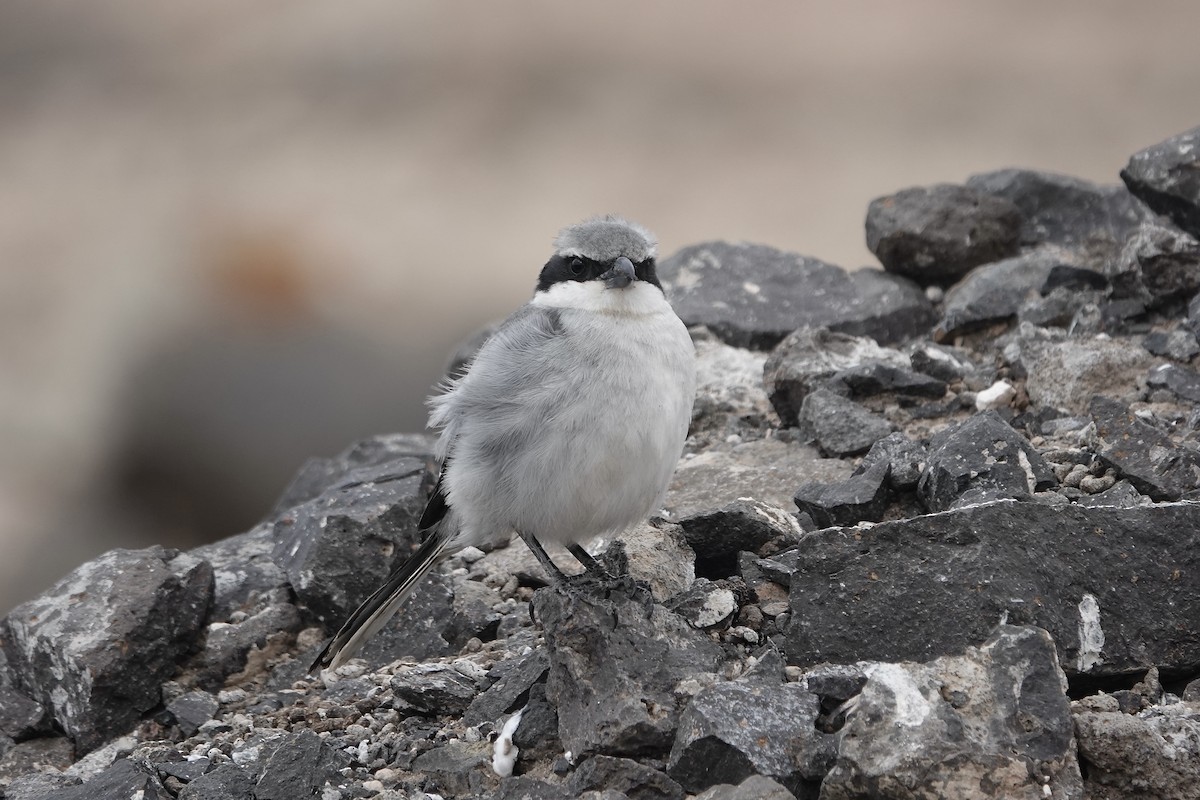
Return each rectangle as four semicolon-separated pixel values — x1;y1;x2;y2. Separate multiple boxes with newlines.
679;498;800;579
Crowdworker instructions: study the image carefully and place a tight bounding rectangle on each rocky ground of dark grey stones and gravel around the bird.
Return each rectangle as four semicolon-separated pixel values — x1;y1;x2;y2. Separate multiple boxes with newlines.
0;128;1200;800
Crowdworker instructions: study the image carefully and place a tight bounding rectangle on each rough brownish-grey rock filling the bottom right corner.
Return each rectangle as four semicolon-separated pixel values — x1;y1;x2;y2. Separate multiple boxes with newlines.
1075;704;1200;800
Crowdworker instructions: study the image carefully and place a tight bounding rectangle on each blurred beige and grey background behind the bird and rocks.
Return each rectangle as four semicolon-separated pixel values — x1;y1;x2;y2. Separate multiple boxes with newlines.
0;0;1200;613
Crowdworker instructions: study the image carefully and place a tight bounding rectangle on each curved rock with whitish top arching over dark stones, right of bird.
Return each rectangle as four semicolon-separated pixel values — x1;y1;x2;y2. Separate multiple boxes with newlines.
763;327;910;426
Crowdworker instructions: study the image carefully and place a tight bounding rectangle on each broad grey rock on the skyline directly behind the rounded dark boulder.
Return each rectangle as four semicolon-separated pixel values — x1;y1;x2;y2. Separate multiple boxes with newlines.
967;169;1150;252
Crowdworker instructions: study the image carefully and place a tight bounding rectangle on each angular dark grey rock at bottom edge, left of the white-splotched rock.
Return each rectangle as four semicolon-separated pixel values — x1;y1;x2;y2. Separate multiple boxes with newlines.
667;680;836;794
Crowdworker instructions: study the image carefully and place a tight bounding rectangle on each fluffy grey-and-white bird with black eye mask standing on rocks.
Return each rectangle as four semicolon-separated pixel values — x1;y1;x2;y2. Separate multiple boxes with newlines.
311;215;696;672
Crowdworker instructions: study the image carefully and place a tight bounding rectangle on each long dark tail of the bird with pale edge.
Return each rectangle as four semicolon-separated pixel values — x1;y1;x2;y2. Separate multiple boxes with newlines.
308;525;450;673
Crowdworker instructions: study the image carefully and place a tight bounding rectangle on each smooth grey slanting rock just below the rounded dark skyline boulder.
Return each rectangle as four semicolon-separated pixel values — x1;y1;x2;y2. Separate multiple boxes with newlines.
934;247;1075;342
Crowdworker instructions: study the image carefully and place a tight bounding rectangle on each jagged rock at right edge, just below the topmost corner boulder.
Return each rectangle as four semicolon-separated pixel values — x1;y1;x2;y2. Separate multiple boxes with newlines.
1105;221;1200;308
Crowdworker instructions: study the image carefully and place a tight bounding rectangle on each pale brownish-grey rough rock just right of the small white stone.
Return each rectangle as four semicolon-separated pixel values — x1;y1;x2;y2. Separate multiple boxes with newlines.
1018;330;1157;414
